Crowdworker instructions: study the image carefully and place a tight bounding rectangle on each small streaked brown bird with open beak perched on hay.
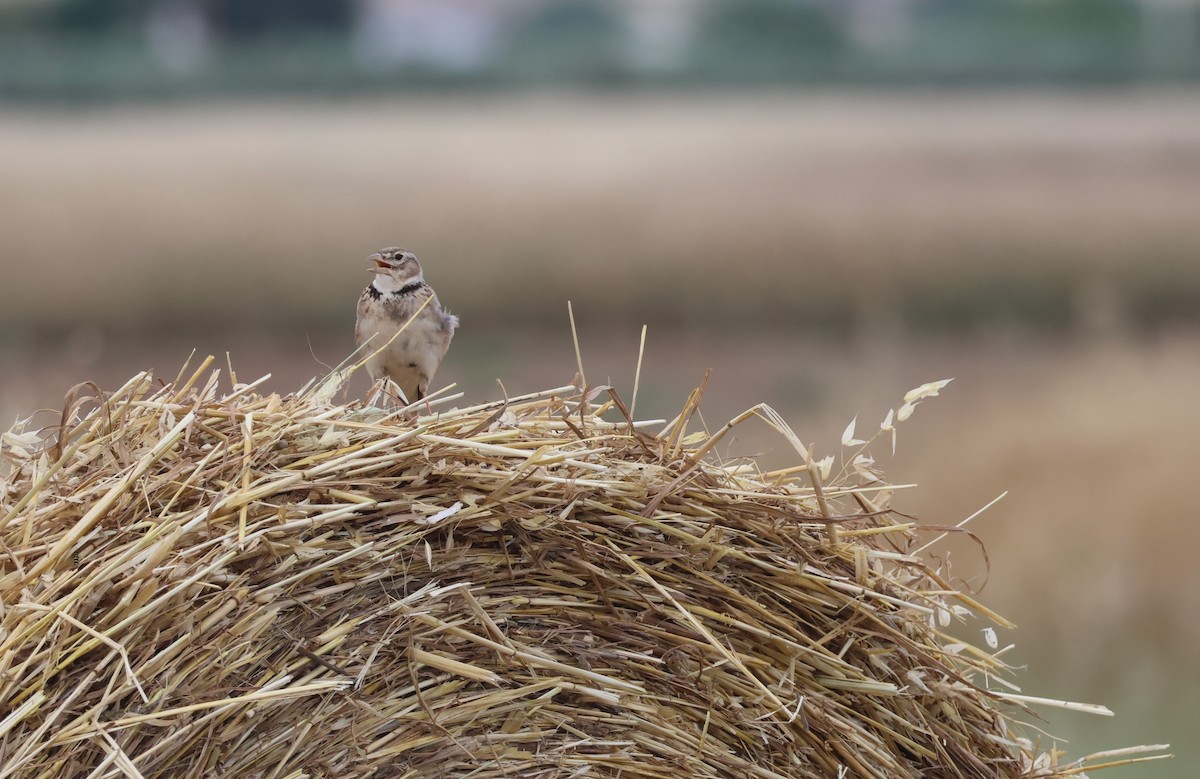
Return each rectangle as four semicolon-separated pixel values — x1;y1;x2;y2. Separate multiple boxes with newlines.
354;246;458;403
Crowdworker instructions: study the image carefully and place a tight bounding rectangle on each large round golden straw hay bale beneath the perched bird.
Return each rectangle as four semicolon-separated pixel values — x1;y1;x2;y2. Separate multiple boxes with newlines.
0;364;1161;779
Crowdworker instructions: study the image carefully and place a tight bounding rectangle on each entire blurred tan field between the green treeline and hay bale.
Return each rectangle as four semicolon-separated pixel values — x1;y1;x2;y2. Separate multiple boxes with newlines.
0;91;1200;778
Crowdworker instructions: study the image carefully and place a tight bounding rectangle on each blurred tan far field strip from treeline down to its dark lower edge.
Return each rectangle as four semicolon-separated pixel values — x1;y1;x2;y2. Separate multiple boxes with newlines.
0;92;1200;331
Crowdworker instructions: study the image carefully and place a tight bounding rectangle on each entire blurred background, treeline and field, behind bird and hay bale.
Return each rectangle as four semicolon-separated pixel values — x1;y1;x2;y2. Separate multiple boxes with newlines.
0;0;1200;778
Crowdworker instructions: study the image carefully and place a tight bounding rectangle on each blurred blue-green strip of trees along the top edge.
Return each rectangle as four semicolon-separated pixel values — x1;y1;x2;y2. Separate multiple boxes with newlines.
0;0;1200;101
